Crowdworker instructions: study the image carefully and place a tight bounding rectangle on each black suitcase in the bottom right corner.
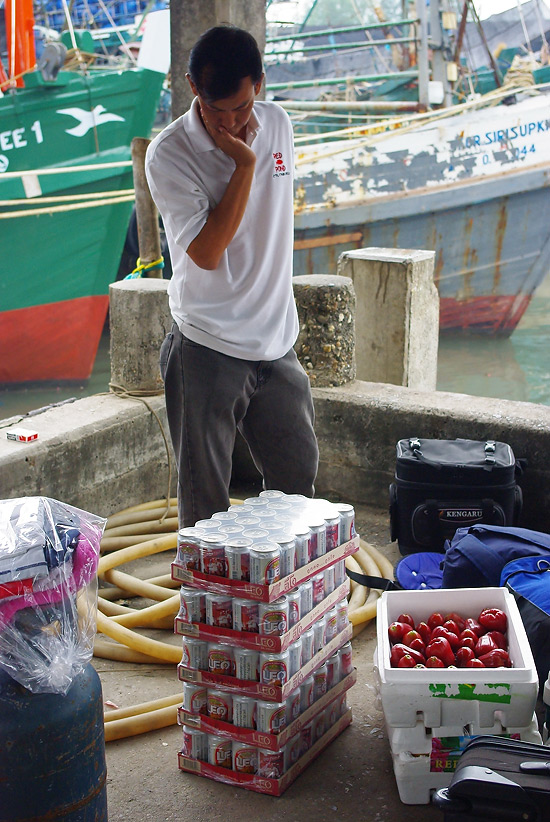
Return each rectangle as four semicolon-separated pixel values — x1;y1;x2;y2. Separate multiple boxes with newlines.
432;736;550;822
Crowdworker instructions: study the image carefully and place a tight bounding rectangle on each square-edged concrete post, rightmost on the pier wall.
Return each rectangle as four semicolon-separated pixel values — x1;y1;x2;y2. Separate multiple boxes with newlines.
338;248;439;391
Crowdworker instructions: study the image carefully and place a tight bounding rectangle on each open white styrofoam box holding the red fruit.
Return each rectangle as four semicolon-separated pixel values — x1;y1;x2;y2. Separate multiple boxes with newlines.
374;588;538;728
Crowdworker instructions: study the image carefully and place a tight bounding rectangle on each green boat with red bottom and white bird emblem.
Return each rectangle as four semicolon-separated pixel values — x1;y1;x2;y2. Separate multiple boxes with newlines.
0;0;165;384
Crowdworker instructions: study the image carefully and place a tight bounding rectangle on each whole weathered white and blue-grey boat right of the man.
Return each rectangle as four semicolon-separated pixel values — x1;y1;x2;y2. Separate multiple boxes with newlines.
267;0;550;336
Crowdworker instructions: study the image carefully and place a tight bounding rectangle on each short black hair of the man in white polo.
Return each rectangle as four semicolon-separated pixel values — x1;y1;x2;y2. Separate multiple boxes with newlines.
189;26;262;101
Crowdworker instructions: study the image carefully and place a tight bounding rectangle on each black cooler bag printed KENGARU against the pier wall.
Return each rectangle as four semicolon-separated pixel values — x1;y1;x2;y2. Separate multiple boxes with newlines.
390;437;522;554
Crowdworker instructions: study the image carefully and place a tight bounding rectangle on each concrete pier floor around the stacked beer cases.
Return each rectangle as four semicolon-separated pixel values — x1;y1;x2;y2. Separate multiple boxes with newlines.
99;498;443;822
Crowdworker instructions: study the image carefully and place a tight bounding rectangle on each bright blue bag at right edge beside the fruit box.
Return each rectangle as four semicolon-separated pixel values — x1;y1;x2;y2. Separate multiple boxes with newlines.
500;555;550;688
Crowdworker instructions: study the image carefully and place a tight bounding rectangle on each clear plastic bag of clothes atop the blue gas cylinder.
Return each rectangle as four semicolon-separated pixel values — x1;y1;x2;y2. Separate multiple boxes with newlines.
0;497;106;694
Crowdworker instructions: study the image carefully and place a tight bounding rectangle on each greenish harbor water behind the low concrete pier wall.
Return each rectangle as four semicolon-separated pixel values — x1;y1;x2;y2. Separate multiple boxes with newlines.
0;274;550;419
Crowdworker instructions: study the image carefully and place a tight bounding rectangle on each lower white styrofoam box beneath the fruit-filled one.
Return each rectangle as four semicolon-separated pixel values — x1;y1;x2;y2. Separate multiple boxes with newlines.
392;715;540;805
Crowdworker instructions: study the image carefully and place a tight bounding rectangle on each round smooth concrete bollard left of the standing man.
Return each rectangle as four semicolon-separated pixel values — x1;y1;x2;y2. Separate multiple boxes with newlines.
109;277;172;394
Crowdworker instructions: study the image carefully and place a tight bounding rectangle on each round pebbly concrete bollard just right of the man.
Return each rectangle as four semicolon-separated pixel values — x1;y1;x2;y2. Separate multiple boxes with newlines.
292;274;355;388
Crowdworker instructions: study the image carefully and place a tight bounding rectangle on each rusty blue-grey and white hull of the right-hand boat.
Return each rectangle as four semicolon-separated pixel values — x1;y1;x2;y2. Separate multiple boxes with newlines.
295;95;550;336
